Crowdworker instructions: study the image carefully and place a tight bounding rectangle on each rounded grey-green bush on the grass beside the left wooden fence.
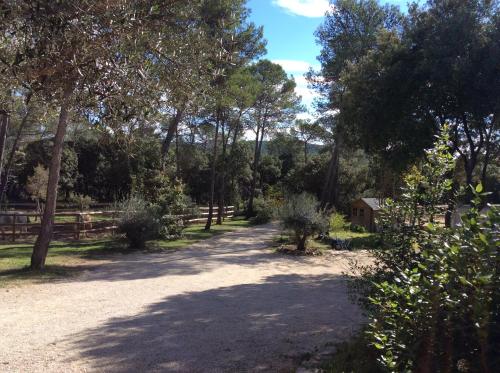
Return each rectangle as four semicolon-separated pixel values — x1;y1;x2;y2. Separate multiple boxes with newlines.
118;197;161;249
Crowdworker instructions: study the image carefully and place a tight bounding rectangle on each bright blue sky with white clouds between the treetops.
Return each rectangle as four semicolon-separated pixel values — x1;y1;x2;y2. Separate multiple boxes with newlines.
247;0;408;110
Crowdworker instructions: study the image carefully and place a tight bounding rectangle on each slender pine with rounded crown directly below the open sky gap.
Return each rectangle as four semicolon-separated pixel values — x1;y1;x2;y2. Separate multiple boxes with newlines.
247;60;299;216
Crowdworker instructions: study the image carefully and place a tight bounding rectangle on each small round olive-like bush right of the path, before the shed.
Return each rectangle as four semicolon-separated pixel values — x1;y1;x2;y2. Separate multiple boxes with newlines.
279;193;329;251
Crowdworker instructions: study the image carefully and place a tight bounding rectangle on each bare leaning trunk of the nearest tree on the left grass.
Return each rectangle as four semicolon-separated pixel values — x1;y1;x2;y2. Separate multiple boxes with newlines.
31;88;72;270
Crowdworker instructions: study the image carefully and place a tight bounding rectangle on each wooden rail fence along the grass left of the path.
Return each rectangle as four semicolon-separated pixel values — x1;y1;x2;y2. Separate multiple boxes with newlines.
0;206;234;242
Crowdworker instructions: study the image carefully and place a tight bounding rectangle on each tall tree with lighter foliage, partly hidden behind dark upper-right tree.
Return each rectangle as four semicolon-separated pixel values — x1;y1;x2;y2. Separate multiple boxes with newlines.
308;0;401;206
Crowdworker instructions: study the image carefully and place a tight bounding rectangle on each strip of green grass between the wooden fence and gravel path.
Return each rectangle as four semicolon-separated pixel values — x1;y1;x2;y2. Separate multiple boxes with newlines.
0;219;250;287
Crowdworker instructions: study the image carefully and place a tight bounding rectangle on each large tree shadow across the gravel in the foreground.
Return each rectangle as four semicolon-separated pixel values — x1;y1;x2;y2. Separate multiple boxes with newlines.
66;274;362;372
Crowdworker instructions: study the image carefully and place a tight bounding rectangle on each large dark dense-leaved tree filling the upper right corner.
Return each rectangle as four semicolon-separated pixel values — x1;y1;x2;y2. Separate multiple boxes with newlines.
343;0;500;192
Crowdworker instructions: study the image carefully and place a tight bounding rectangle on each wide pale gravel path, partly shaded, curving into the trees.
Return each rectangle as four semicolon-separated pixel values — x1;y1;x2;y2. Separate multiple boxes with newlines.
0;225;368;372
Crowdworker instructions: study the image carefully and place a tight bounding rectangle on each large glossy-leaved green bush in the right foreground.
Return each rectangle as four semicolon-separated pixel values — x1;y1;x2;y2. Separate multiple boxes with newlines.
358;126;500;372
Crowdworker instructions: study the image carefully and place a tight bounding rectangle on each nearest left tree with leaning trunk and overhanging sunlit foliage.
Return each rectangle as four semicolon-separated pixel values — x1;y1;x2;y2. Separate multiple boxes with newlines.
0;0;207;269
